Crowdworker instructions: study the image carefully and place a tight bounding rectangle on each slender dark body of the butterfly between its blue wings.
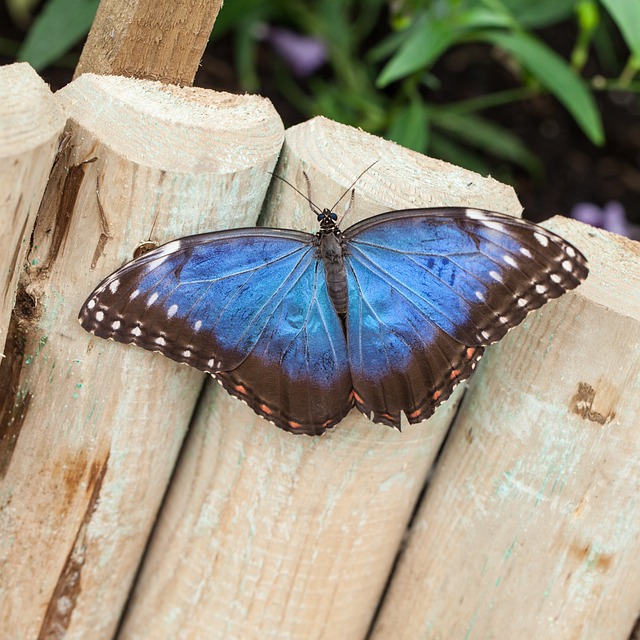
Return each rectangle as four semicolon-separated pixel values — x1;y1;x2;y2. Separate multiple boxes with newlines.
317;209;348;316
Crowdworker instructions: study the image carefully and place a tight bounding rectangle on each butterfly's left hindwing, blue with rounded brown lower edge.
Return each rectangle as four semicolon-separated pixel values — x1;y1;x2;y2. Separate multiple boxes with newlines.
218;261;353;435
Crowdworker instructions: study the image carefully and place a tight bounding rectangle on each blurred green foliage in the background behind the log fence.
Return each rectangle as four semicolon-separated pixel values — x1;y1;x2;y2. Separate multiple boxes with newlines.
5;0;640;174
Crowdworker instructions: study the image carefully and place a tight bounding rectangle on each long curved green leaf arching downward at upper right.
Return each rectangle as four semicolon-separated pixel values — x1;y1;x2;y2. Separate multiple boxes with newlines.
479;31;604;145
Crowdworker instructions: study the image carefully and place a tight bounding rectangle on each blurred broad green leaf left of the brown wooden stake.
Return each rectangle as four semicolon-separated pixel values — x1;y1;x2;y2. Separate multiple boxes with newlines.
18;0;99;70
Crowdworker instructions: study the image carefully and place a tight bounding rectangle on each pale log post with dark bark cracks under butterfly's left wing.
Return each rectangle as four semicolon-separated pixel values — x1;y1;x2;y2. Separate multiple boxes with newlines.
0;74;283;638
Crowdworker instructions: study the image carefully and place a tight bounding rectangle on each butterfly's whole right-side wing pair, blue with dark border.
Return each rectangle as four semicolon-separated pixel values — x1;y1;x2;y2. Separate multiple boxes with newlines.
344;208;588;428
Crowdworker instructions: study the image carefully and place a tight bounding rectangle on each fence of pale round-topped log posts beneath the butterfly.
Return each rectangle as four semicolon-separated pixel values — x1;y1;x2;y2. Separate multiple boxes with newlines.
0;64;640;640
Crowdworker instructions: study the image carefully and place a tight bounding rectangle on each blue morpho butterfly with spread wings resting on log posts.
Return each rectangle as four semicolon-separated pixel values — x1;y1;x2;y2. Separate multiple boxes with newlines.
79;169;588;435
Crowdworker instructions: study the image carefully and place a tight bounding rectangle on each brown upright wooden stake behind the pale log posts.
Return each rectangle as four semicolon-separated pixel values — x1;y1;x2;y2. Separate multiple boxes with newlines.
75;0;222;86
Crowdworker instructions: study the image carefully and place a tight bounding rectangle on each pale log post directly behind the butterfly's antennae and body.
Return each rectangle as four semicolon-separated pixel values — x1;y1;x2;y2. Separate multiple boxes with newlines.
120;118;520;640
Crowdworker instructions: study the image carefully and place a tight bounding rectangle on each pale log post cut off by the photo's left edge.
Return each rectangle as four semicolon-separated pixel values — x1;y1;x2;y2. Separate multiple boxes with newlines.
0;62;64;356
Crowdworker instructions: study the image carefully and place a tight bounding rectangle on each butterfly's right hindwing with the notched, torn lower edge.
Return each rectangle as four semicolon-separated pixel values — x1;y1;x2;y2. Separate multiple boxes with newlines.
347;256;483;428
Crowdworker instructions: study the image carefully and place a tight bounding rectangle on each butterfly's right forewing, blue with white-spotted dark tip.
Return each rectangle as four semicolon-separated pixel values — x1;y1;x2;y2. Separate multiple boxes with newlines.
344;208;588;346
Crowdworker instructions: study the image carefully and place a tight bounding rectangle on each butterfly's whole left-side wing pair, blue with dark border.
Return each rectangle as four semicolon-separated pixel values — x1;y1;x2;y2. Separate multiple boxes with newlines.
79;229;353;434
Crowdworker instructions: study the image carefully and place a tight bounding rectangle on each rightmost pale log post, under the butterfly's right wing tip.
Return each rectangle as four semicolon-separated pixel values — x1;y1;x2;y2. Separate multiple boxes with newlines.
372;218;640;640
